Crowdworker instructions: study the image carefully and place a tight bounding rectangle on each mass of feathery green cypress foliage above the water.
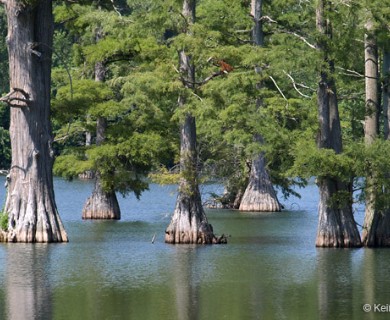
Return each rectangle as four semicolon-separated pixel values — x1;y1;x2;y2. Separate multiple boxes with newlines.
48;0;389;212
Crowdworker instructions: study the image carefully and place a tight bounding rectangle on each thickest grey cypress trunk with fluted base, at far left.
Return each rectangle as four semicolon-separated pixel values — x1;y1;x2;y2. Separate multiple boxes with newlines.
1;0;68;242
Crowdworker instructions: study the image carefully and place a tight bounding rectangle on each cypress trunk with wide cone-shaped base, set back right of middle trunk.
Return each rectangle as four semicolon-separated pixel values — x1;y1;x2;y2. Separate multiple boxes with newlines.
239;0;282;212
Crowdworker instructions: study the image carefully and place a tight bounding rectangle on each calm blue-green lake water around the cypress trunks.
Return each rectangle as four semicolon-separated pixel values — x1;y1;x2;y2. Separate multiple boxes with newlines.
0;177;390;320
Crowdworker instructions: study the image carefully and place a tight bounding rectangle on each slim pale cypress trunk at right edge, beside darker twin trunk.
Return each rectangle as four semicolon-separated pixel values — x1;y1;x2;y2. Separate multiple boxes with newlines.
362;20;390;247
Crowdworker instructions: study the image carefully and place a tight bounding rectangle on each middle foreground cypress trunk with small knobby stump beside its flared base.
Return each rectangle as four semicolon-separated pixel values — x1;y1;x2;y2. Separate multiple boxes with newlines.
165;0;226;244
